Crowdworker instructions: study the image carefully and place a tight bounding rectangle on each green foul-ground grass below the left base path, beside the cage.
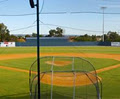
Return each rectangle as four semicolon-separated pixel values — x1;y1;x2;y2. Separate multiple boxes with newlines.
0;69;29;99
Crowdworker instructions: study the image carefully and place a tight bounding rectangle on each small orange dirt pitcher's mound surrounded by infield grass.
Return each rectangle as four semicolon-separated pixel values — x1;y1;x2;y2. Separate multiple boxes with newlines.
46;61;71;66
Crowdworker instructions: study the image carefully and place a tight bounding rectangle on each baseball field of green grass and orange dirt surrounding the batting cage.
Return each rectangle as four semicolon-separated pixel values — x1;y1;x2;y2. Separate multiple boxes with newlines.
0;46;120;99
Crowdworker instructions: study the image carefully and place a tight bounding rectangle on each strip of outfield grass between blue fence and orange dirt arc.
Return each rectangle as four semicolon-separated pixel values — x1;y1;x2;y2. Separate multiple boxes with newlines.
0;46;120;54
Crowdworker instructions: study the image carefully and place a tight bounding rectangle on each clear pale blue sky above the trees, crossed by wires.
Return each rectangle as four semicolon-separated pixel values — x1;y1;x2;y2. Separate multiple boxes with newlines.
0;0;120;35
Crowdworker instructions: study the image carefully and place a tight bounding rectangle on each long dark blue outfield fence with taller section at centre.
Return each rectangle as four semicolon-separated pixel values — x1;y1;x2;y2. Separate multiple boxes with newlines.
16;37;111;46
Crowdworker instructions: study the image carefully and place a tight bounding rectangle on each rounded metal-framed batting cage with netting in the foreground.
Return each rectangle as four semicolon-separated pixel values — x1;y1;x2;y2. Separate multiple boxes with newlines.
29;56;101;99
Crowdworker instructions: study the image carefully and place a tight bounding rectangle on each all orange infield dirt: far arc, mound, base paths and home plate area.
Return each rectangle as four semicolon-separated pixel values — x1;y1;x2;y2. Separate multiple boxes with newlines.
0;53;120;87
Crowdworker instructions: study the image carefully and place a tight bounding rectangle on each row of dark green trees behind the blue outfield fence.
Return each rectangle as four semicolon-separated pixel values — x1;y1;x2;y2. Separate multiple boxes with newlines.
0;23;120;42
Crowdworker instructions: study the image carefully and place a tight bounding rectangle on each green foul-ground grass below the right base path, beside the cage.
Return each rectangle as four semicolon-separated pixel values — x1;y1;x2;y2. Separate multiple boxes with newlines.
99;68;120;99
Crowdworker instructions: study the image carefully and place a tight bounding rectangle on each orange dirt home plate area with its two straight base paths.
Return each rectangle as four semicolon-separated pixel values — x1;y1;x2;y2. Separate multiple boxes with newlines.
0;64;120;87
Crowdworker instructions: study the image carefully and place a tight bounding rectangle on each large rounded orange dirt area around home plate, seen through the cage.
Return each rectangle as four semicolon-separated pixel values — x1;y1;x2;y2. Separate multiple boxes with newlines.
40;72;97;87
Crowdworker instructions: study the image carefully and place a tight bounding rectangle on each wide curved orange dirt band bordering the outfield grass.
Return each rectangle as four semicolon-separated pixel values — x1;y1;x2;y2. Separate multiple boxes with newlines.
0;53;120;61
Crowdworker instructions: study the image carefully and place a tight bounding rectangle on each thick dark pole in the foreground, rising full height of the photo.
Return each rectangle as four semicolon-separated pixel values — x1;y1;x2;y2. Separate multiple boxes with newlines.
29;0;40;99
